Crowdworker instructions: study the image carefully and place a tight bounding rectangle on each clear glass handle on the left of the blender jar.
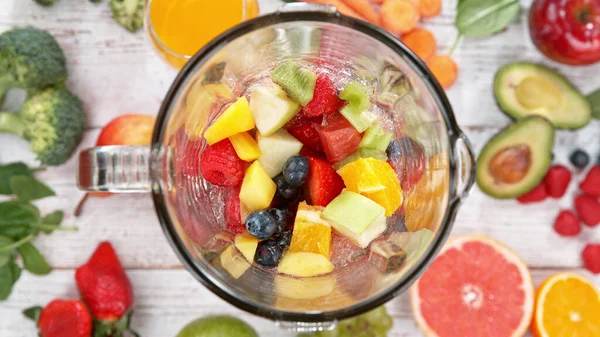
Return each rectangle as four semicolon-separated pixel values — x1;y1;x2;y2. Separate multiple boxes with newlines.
77;146;151;193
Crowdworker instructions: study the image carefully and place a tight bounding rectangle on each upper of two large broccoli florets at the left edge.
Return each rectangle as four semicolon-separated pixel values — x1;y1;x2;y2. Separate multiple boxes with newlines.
0;27;67;97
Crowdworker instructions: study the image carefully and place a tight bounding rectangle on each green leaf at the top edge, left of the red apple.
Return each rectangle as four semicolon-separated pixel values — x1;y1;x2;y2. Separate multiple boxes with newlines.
455;0;521;37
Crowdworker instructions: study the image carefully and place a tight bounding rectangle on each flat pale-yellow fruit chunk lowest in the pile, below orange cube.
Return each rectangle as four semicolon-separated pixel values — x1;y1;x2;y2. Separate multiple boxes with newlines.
277;251;334;277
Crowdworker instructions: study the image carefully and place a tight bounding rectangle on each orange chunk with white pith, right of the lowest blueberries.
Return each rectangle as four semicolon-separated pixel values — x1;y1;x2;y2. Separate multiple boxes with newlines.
290;202;331;258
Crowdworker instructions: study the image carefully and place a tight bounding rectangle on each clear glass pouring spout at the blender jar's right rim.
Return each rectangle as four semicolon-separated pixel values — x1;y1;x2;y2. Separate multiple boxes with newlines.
454;134;476;202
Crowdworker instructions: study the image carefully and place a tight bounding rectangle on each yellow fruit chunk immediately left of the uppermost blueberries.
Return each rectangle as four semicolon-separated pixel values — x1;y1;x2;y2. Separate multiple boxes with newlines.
240;161;277;212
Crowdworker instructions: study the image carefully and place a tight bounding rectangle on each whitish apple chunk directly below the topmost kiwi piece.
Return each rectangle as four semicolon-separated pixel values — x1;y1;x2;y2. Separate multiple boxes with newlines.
250;85;300;136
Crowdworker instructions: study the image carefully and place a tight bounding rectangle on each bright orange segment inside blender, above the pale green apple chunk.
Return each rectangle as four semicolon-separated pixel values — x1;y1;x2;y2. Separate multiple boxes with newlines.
338;158;402;216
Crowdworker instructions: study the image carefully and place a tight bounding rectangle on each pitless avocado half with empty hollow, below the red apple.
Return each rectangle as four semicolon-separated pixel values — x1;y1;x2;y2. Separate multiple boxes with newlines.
494;62;592;129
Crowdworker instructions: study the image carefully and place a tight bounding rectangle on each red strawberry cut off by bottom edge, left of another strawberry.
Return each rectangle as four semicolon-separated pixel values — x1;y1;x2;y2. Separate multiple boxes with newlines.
38;299;92;337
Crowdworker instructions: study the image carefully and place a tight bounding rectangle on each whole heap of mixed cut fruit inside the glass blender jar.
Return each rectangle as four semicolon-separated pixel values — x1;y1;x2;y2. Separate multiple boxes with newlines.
176;61;440;299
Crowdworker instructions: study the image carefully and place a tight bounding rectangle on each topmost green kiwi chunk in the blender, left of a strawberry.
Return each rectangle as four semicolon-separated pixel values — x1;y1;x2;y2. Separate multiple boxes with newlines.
271;61;317;106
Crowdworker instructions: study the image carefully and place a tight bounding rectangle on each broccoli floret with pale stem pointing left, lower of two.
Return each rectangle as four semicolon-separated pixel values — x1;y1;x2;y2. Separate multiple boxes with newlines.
0;86;86;166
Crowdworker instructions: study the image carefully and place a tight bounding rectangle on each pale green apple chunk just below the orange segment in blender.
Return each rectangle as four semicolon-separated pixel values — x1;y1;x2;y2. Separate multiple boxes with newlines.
321;191;387;248
